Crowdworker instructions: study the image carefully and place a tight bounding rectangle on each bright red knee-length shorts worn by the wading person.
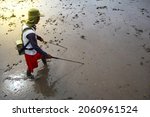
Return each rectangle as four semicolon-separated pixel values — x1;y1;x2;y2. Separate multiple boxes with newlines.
25;53;42;72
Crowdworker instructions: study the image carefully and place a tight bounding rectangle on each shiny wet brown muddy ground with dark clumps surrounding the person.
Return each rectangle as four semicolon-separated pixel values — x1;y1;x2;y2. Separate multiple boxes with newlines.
0;0;150;100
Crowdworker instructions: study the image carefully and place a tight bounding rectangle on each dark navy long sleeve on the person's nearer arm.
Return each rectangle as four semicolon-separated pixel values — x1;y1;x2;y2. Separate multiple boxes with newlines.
27;33;47;56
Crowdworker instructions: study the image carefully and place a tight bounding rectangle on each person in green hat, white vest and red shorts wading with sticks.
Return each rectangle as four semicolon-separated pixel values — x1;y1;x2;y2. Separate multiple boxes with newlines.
22;8;52;79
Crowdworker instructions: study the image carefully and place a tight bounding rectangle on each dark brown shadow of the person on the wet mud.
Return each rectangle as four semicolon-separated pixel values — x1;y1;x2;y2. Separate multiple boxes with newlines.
34;67;57;97
